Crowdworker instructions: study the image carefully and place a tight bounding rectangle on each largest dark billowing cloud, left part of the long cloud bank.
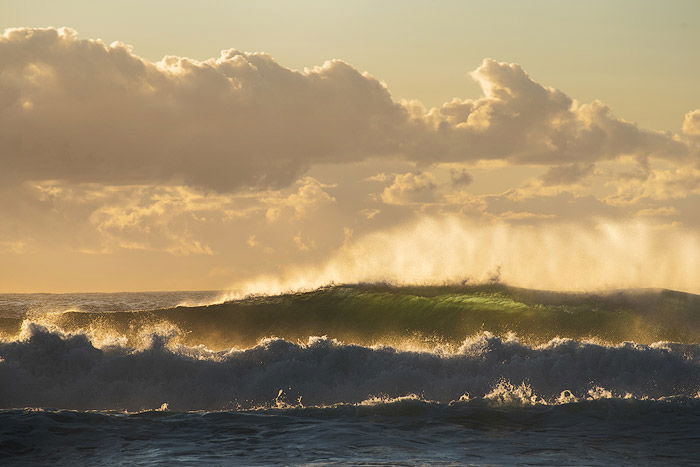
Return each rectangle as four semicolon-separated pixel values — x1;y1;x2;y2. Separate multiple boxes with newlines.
0;29;406;190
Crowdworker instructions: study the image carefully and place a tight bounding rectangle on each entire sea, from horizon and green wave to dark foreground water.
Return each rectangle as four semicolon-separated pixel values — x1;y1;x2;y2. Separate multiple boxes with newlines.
0;284;700;466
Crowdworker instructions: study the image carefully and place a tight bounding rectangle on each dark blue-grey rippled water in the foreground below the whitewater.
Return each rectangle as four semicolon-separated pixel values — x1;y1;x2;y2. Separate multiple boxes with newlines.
0;400;700;465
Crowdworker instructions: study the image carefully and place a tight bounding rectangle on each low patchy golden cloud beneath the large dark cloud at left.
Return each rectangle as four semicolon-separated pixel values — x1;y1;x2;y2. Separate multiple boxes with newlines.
8;177;335;256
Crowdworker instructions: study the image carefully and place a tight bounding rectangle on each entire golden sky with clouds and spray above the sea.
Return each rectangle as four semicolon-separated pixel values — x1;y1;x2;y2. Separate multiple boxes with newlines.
0;0;700;292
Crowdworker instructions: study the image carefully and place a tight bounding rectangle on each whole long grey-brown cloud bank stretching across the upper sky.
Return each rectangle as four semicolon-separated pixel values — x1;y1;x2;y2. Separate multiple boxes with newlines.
0;28;696;192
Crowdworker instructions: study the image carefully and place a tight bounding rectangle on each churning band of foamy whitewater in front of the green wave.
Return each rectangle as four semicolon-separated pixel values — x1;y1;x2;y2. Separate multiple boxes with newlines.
0;323;700;410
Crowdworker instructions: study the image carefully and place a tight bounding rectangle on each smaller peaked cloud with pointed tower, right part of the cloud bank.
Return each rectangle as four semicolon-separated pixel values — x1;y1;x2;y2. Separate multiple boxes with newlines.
416;59;688;165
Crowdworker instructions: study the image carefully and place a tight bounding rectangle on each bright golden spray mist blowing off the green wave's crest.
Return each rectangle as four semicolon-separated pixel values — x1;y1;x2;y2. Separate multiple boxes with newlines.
219;216;700;301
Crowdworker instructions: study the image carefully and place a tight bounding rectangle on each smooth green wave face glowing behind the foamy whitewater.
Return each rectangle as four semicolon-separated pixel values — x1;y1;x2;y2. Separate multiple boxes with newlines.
2;284;700;348
